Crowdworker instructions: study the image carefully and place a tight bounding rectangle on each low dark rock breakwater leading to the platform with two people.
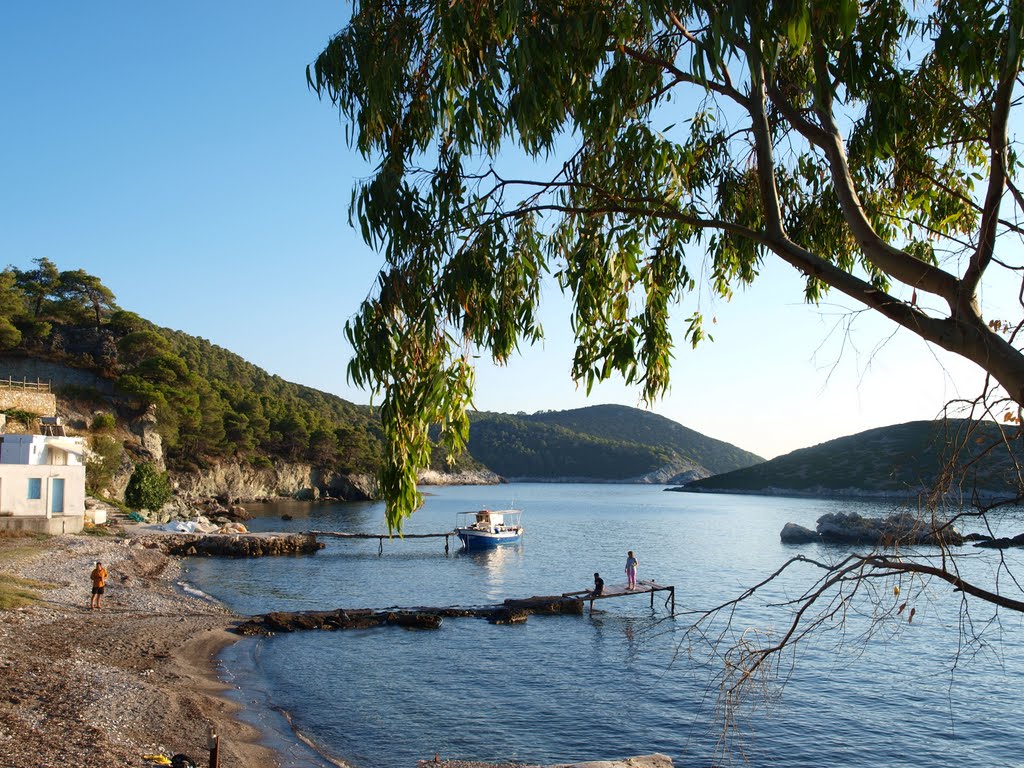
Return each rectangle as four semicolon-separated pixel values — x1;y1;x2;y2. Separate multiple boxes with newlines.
234;595;584;635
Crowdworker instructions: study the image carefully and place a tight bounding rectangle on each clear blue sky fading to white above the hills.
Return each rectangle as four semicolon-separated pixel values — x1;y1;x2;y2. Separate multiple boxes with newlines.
0;0;997;458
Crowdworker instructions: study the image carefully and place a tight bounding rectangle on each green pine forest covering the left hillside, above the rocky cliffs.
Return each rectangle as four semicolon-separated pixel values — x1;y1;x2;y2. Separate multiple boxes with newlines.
0;259;381;481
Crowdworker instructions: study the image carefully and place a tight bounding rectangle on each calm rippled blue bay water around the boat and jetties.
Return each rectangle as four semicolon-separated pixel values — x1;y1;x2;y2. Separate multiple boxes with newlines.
187;483;1024;768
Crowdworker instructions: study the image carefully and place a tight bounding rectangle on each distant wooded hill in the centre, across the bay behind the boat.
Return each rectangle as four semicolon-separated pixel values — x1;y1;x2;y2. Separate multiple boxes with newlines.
469;406;764;482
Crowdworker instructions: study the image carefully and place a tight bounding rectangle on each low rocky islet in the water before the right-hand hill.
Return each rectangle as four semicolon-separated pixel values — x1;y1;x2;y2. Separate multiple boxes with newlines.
780;512;964;547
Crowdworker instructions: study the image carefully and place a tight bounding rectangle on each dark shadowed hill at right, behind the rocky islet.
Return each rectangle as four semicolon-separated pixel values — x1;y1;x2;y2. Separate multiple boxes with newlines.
673;419;1024;497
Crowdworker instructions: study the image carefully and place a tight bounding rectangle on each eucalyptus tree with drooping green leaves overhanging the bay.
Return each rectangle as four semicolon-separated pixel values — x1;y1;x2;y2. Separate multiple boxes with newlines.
306;0;1024;527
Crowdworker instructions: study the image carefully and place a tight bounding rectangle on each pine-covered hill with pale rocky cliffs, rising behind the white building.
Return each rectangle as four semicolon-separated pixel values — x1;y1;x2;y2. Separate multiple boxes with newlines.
0;259;491;498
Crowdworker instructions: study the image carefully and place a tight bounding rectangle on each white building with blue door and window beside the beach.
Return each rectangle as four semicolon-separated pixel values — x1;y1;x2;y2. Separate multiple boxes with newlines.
0;430;85;534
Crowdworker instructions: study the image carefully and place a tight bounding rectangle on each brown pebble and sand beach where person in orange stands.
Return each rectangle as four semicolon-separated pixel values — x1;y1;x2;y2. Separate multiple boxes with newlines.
0;536;282;768
